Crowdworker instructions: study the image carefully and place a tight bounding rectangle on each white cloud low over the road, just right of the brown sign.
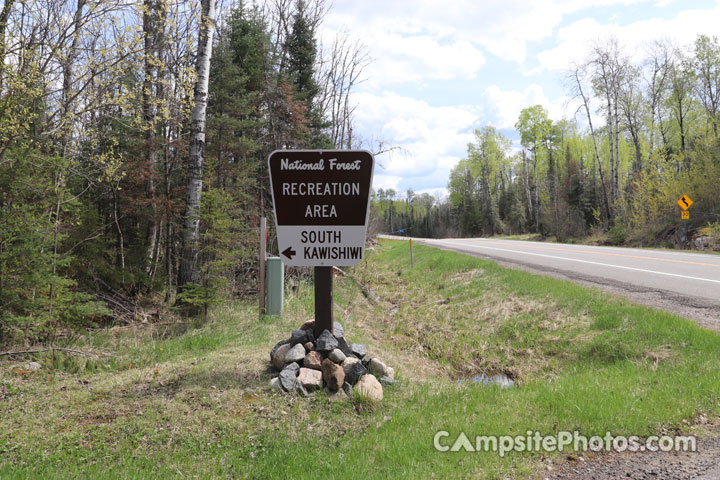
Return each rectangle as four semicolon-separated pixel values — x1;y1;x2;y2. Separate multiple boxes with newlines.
353;92;477;191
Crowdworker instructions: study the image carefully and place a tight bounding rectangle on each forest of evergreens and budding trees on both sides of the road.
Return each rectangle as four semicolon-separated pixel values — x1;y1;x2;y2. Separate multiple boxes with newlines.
0;0;720;344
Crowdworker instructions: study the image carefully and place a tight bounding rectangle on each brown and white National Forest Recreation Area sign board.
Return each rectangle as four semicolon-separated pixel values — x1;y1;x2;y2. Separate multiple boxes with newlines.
268;150;375;267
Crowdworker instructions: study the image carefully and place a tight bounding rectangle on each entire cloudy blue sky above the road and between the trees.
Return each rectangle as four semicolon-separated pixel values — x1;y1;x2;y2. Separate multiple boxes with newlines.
321;0;720;198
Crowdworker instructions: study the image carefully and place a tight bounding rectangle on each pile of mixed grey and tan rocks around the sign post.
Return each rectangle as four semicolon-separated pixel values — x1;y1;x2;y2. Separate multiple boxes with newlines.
270;322;398;402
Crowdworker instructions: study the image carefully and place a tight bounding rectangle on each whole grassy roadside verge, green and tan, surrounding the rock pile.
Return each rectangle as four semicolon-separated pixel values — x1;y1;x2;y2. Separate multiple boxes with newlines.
0;241;720;479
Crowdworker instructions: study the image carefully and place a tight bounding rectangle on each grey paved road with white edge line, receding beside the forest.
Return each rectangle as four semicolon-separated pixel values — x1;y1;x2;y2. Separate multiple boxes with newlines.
388;237;720;330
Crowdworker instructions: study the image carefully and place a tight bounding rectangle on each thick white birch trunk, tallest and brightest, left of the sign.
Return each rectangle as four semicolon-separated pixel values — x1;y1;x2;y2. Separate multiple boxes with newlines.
178;0;216;288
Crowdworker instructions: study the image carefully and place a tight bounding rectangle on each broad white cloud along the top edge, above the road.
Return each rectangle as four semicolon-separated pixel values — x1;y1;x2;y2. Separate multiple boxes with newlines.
324;0;650;80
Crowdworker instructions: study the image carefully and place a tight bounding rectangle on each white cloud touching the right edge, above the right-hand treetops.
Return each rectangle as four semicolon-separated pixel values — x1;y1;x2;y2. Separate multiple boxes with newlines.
532;5;720;73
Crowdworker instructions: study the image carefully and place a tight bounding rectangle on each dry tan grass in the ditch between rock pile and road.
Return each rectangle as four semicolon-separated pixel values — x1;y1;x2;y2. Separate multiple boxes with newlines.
332;246;593;381
